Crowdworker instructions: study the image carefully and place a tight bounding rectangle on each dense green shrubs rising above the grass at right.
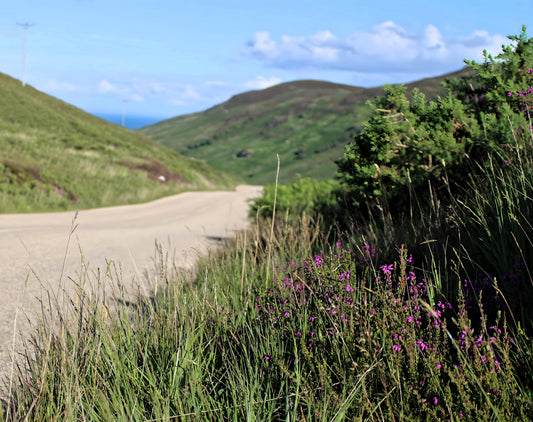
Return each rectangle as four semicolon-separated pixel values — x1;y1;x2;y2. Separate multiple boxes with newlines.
337;28;533;205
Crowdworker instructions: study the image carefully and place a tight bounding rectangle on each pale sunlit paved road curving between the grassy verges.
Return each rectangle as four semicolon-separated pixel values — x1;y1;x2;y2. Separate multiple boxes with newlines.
0;186;260;394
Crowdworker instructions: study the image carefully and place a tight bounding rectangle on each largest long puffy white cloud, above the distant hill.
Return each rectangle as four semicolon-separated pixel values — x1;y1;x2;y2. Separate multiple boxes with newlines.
245;21;509;74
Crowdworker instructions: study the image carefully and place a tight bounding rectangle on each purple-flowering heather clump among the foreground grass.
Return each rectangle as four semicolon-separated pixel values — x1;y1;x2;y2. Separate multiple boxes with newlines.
249;244;527;420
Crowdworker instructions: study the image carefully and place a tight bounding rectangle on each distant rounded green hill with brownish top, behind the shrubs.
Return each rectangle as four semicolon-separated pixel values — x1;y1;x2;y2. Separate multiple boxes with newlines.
139;71;464;184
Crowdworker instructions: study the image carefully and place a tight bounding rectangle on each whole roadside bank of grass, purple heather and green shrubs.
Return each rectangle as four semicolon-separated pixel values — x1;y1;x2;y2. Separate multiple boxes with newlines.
3;28;533;421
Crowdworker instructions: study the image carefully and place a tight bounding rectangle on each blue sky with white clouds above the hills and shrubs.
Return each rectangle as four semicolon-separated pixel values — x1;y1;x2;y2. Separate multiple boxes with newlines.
0;0;533;117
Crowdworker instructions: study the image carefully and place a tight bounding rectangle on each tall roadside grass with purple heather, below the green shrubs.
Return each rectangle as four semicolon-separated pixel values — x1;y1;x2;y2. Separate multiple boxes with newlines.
3;131;533;421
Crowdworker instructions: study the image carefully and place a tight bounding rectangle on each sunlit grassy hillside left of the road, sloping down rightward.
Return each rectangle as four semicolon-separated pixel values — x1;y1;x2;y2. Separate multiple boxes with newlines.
0;73;236;212
